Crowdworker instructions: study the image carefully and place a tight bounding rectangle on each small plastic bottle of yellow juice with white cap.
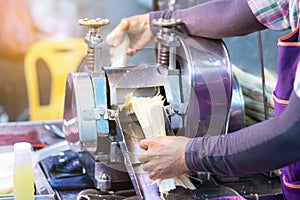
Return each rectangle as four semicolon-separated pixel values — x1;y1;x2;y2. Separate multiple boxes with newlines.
14;142;34;200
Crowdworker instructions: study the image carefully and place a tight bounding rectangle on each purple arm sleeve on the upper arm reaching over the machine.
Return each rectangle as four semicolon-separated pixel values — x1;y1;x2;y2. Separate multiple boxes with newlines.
150;0;266;38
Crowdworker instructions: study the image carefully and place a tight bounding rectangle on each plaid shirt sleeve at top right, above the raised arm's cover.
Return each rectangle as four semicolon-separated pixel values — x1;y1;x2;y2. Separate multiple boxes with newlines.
247;0;300;30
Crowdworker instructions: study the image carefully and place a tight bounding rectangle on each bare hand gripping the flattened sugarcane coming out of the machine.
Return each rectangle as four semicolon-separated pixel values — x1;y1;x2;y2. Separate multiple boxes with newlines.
139;136;190;179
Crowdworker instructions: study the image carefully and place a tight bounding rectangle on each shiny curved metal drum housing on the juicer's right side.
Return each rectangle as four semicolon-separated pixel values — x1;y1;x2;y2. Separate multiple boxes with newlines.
173;36;232;137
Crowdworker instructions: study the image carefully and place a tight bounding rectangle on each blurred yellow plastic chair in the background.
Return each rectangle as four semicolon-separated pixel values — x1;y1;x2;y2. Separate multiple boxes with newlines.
24;38;87;121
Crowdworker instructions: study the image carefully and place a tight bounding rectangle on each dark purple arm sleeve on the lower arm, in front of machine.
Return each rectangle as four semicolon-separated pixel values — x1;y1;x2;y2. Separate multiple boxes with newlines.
185;92;300;176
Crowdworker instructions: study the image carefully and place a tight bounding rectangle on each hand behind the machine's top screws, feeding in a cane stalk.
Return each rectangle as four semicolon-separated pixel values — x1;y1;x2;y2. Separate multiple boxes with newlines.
106;14;153;57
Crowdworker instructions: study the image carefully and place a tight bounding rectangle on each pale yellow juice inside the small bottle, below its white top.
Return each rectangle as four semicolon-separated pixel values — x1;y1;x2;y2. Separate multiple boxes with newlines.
14;163;34;200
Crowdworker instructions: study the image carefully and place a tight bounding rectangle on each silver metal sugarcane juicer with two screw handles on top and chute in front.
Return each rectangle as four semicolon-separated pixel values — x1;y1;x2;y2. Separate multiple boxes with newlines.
63;18;244;199
